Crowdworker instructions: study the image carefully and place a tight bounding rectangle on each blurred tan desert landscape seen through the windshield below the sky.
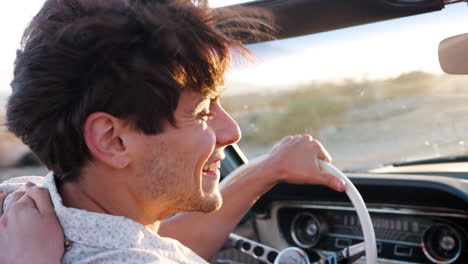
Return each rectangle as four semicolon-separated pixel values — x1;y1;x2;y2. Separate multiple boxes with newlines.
222;71;468;169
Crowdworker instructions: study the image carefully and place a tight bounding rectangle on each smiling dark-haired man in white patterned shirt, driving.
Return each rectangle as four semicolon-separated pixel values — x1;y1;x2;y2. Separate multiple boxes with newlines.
0;0;344;263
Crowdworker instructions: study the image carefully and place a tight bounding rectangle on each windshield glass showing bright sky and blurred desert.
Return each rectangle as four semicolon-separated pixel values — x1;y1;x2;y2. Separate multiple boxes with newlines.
222;4;468;169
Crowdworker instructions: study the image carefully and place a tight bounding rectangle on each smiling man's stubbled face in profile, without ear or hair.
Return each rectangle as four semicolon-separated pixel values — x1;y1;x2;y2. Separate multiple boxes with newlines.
132;91;240;214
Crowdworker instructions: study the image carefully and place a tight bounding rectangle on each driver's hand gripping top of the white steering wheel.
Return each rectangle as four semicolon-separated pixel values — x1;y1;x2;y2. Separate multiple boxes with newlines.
265;135;345;191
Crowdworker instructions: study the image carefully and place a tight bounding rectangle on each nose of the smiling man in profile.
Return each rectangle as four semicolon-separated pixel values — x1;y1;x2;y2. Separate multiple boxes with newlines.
211;105;241;146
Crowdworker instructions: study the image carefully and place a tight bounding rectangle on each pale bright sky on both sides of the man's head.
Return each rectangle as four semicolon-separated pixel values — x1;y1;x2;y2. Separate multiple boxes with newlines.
0;0;468;98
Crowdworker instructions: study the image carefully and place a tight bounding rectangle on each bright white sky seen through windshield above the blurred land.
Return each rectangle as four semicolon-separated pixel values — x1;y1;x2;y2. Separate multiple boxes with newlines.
222;3;468;93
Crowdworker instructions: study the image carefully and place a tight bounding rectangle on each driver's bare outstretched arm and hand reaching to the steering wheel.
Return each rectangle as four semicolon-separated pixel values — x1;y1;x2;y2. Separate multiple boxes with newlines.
159;136;344;260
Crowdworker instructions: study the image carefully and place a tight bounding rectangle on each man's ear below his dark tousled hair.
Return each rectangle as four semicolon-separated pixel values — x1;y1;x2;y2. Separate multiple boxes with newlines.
83;112;131;169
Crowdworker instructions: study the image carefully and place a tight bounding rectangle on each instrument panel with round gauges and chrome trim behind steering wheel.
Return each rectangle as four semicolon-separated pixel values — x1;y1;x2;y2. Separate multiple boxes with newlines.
277;205;468;264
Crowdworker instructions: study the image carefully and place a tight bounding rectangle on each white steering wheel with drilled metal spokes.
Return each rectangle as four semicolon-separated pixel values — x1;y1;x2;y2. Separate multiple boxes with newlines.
220;155;377;264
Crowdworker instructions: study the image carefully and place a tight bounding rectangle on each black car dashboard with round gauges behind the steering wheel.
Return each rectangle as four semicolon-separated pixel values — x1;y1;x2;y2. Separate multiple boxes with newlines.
252;173;468;263
